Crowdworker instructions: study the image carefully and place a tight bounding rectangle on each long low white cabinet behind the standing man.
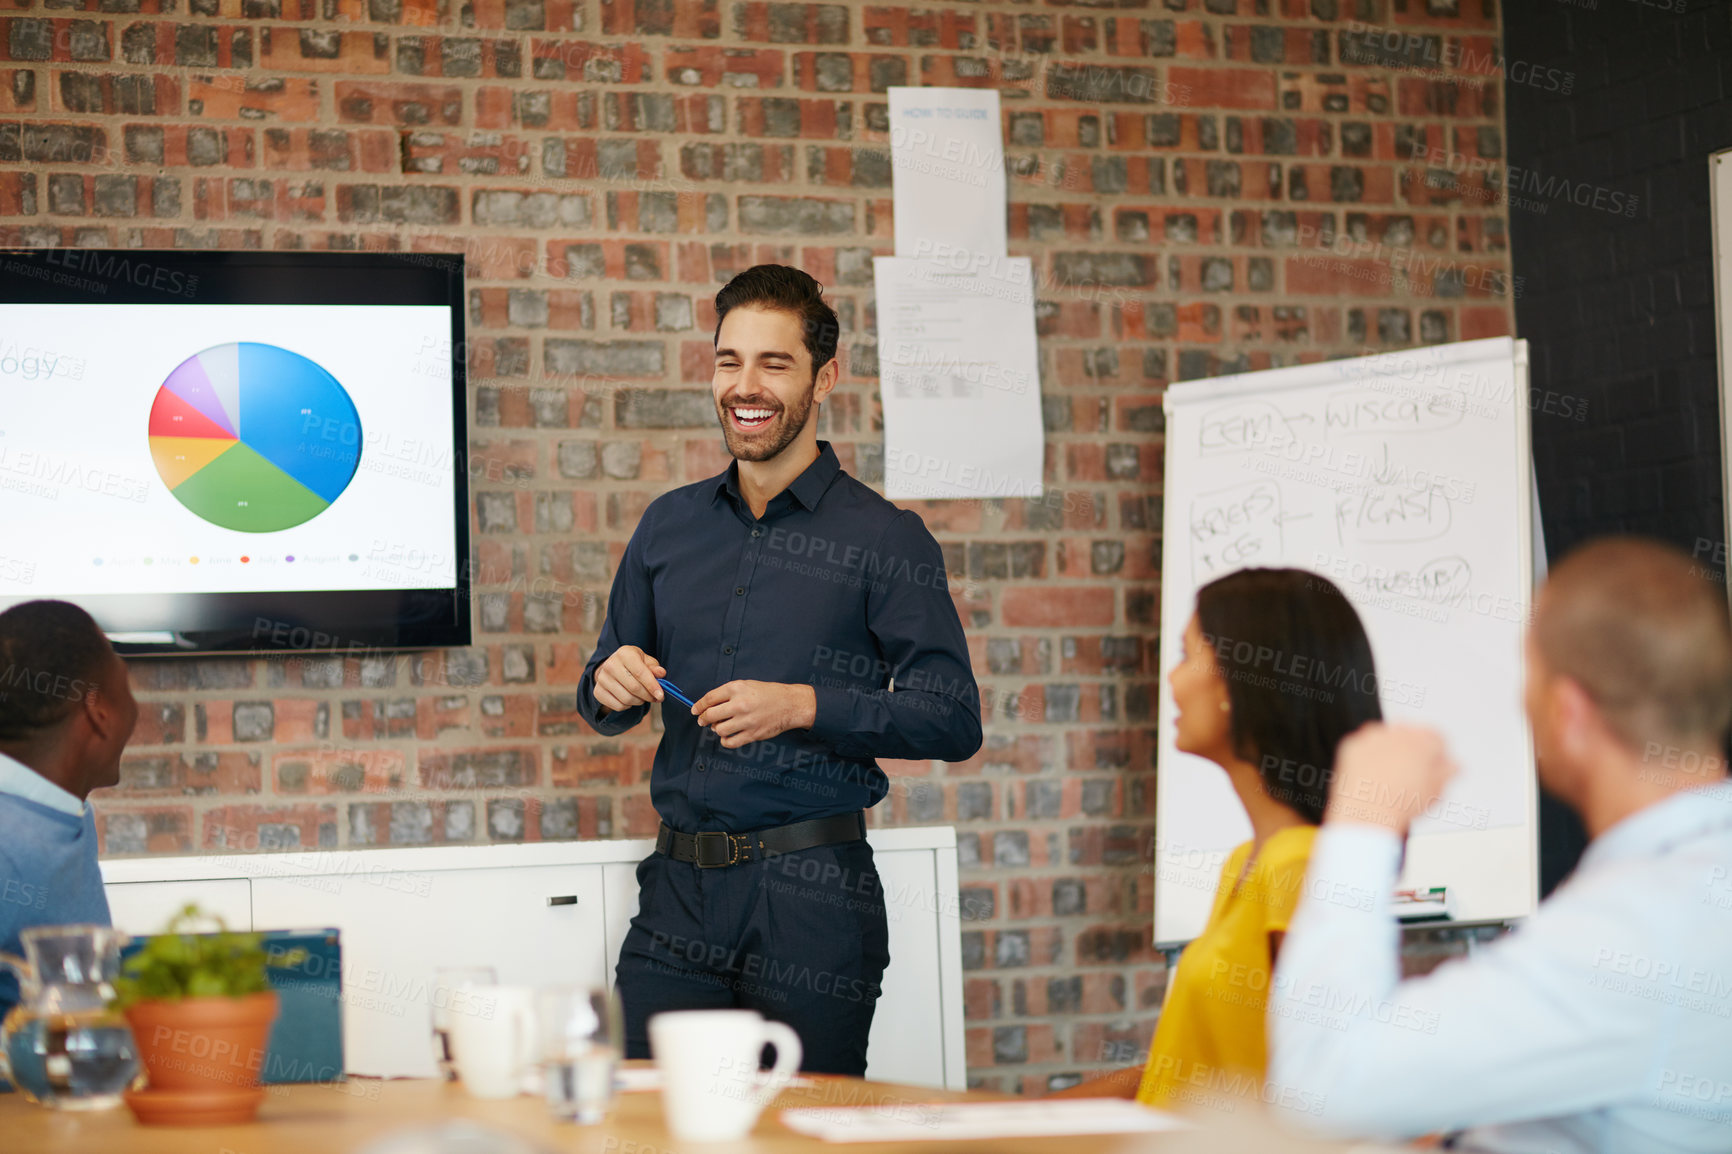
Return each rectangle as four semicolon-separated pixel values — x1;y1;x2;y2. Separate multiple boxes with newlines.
102;827;966;1090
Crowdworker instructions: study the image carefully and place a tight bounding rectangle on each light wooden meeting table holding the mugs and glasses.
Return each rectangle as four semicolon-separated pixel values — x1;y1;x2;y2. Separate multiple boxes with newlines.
0;1076;1370;1154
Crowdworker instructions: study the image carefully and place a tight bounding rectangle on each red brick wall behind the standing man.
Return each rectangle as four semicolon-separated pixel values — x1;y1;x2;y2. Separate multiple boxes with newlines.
0;0;1510;1090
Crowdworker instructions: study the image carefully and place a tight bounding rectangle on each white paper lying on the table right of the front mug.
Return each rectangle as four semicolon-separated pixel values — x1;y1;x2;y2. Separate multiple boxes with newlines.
781;1099;1190;1142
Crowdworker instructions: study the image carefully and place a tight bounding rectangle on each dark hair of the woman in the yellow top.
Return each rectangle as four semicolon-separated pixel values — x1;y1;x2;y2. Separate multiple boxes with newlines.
1197;568;1384;825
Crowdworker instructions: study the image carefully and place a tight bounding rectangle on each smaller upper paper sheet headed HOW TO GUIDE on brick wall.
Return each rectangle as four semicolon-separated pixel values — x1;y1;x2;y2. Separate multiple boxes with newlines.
890;88;1006;263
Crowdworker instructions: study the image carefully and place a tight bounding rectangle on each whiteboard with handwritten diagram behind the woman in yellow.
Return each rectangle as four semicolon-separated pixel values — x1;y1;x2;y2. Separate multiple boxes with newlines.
1155;338;1538;946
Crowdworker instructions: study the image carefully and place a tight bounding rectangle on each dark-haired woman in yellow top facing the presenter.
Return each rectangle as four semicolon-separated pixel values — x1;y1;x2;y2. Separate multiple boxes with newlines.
1060;568;1382;1109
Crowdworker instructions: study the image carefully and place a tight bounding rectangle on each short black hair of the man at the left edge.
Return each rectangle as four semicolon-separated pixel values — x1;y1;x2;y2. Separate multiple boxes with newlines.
0;601;114;742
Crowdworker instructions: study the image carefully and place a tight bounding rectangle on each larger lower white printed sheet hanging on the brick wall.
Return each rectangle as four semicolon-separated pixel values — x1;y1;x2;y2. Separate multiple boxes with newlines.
875;256;1044;501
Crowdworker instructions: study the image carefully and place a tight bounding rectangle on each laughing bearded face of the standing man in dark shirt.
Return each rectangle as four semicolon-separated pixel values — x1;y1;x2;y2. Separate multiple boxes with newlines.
710;305;838;461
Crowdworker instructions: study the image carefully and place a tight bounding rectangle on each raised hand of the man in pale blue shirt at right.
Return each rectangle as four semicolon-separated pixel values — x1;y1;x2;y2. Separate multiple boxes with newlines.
1323;721;1457;835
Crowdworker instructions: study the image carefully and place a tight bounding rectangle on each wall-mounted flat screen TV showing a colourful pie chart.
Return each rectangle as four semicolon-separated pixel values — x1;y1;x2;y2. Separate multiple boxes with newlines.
0;250;469;655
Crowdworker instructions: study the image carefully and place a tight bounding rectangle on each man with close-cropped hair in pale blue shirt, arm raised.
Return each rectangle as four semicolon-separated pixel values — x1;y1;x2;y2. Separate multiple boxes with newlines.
1268;539;1732;1154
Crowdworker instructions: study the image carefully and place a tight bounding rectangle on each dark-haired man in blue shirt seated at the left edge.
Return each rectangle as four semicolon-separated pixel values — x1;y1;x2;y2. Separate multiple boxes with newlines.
0;601;139;1018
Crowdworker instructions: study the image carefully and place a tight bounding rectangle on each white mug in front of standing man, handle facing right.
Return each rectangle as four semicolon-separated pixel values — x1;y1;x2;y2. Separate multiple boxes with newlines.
650;1010;800;1142
